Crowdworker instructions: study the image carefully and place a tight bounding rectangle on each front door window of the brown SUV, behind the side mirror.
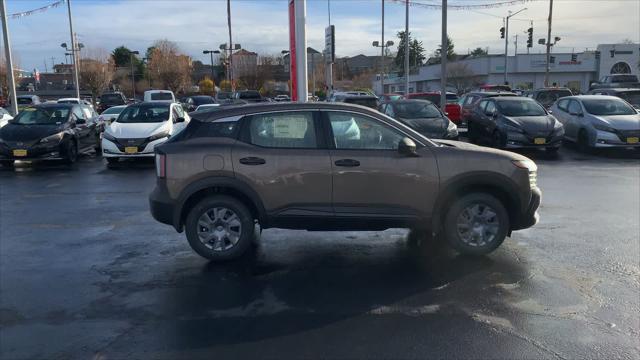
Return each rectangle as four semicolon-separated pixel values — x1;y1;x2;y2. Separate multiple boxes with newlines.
327;111;404;150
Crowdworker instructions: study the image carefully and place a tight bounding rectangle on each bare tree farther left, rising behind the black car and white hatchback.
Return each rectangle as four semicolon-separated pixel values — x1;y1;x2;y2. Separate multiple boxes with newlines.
79;49;115;104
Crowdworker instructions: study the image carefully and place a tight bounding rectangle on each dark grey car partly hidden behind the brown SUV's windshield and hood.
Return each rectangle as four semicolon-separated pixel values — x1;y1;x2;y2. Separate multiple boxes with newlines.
380;100;458;140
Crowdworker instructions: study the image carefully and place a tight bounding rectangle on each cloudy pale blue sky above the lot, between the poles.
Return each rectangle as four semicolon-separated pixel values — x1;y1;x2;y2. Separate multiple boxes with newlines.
6;0;640;71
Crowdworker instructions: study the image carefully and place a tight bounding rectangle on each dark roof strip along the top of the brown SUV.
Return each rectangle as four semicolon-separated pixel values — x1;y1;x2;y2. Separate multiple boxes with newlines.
192;102;380;121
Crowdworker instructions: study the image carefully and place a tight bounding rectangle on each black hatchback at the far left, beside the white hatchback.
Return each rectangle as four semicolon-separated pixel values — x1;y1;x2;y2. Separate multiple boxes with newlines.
0;103;100;166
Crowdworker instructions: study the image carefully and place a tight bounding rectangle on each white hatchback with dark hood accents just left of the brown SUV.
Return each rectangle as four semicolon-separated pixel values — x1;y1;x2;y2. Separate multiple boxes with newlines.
102;102;191;164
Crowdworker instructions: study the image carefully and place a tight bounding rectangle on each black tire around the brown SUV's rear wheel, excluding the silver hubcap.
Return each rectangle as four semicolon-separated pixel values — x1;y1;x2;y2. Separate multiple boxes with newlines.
185;195;255;261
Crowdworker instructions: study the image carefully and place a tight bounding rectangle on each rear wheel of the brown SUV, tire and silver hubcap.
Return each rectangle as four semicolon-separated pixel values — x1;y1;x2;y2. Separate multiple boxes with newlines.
185;195;255;261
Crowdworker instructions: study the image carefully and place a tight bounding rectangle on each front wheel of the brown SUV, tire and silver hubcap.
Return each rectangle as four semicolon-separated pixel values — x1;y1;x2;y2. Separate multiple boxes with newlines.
444;193;509;255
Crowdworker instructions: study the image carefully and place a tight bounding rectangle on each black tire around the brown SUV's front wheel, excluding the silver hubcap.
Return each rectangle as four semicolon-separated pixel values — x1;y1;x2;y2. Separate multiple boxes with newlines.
443;193;510;256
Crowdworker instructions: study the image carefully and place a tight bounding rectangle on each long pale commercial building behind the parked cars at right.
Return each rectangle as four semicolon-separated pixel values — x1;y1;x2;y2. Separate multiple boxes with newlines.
374;44;640;93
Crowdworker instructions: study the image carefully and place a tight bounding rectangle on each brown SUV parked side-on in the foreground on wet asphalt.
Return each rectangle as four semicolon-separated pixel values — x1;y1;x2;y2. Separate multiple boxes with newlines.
150;103;540;260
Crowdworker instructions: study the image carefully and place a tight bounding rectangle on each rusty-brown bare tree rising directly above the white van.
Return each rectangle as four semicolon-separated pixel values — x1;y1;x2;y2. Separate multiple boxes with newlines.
149;40;192;93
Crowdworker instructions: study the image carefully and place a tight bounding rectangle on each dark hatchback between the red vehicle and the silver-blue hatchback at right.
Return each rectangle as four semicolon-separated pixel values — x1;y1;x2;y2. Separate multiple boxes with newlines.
467;97;564;152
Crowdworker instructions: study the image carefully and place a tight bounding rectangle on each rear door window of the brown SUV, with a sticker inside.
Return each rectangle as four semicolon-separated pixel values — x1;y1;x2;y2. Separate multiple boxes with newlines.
248;111;318;149
